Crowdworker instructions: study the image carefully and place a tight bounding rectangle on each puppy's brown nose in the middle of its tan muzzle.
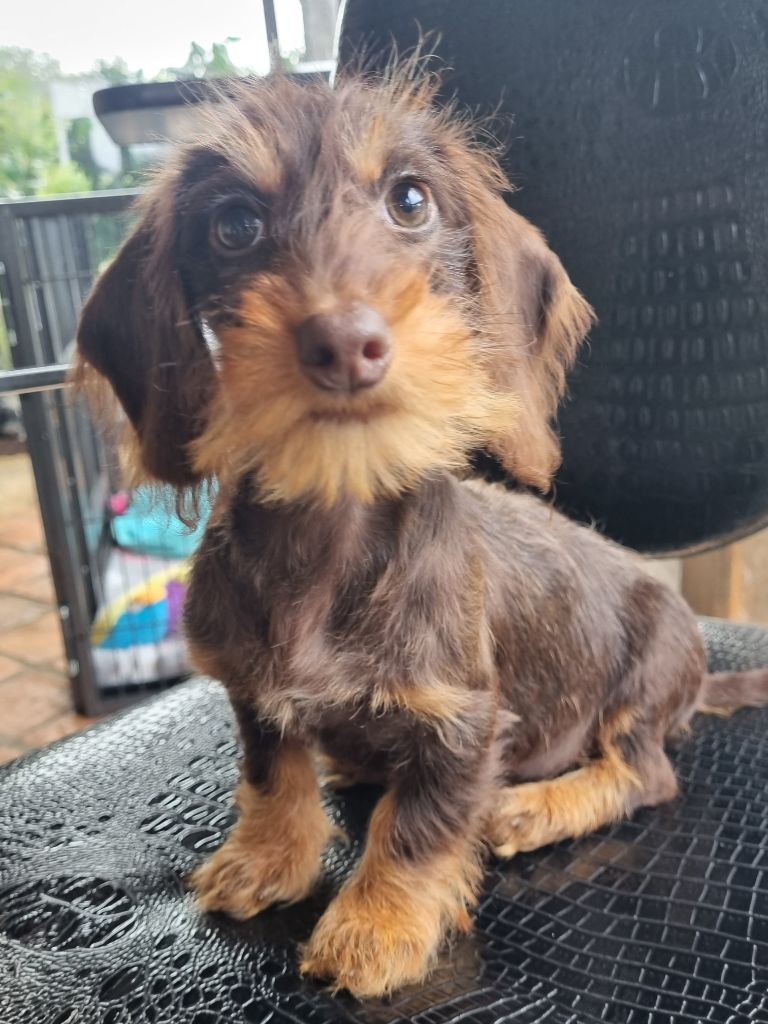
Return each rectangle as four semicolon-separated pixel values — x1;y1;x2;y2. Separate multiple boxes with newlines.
296;305;392;391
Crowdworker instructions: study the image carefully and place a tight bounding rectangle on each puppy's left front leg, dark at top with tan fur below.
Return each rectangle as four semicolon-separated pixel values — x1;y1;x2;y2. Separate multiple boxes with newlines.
188;705;332;919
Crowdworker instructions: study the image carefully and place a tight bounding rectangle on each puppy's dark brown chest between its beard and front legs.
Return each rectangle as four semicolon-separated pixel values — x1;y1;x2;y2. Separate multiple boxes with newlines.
186;495;487;730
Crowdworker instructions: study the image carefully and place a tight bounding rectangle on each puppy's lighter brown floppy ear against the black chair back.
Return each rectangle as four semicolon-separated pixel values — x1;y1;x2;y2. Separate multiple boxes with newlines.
470;188;594;490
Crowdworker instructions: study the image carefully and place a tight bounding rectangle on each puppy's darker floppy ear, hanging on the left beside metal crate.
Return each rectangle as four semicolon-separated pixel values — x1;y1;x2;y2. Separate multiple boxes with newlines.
76;187;215;487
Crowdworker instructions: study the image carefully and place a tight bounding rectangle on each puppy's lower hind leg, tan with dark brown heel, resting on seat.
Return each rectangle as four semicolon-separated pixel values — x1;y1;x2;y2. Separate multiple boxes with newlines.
486;710;677;857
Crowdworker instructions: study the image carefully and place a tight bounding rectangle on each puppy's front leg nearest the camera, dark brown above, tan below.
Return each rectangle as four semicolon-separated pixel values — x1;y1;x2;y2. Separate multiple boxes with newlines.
301;695;492;996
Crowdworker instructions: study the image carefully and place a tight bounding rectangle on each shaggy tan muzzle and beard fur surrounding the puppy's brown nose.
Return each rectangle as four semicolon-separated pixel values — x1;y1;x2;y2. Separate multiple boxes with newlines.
194;266;517;506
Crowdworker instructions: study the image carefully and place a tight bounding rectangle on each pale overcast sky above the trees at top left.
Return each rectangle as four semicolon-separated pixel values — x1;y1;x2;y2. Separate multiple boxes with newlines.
6;0;303;78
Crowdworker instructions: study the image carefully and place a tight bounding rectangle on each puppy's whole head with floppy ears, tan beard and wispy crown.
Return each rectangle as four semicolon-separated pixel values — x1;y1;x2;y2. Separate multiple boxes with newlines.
78;71;591;504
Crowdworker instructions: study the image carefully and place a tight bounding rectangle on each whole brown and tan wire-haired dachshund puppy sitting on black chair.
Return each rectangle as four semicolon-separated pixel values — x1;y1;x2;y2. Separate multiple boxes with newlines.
79;75;768;995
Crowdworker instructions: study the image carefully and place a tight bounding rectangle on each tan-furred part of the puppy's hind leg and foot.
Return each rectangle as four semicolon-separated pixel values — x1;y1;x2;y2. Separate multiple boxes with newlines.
486;709;642;857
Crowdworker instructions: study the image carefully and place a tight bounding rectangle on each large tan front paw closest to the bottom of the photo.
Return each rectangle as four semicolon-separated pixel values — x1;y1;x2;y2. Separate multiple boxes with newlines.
301;885;448;997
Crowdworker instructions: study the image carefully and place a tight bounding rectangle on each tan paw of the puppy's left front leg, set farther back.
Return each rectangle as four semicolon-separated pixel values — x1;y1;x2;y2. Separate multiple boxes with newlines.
187;836;319;921
